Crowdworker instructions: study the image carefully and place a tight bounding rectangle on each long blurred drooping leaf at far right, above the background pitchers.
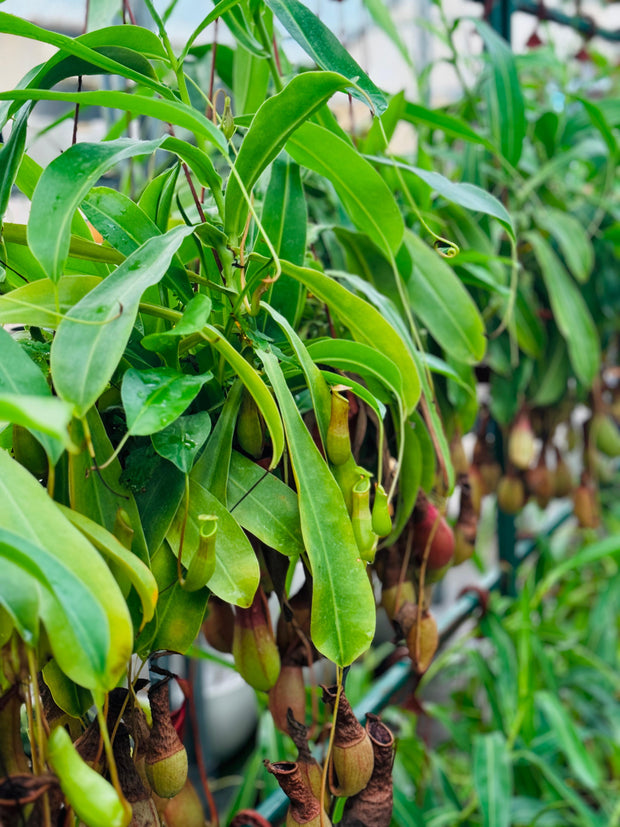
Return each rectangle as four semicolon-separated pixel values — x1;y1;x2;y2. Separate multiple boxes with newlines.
526;232;601;387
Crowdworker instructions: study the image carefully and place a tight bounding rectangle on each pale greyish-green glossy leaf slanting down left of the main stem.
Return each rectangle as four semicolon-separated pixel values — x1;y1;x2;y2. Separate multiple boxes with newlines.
51;227;192;416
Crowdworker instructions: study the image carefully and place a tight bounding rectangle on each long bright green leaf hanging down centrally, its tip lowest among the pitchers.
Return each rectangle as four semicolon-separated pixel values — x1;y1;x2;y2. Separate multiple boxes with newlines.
260;352;375;666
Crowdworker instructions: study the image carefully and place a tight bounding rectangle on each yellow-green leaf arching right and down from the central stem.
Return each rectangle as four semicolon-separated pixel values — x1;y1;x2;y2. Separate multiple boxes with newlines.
253;261;420;412
